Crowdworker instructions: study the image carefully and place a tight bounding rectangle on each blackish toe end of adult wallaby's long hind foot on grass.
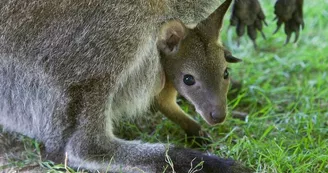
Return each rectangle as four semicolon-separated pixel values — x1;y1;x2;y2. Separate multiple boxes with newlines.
168;148;253;173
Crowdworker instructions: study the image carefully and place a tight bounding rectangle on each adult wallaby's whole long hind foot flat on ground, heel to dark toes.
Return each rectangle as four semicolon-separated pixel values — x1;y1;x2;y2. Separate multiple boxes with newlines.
67;129;248;173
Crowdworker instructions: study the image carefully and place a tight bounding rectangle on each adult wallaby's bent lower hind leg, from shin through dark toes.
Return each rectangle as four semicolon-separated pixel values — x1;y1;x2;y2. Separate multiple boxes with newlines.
65;82;240;173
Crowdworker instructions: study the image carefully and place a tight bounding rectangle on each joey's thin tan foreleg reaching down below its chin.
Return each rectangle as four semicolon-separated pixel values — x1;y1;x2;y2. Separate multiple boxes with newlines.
156;80;207;140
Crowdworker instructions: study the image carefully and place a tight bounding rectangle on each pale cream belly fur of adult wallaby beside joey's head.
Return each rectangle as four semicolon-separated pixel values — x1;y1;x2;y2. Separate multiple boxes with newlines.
112;35;162;118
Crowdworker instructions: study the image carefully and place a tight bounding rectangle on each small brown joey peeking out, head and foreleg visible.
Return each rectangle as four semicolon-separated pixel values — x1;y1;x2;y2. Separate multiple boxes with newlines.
156;17;241;141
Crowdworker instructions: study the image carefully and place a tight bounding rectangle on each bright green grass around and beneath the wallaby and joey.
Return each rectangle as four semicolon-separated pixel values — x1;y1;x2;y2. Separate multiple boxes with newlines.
1;0;328;173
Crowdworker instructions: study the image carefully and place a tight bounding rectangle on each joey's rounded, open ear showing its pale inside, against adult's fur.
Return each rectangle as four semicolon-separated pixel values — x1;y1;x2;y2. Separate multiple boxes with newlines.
157;20;187;55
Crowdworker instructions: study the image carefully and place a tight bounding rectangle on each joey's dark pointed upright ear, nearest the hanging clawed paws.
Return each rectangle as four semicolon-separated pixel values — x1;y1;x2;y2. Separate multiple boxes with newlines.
196;0;232;41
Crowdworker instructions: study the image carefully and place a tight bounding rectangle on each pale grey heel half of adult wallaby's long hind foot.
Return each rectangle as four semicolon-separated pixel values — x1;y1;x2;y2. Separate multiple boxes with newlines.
66;130;166;173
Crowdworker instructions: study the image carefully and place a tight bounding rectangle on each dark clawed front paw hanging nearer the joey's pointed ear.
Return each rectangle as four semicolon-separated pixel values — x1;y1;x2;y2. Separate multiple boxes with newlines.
230;0;267;47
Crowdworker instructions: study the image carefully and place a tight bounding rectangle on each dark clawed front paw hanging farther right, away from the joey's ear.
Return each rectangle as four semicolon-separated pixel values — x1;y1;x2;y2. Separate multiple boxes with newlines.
274;0;304;44
